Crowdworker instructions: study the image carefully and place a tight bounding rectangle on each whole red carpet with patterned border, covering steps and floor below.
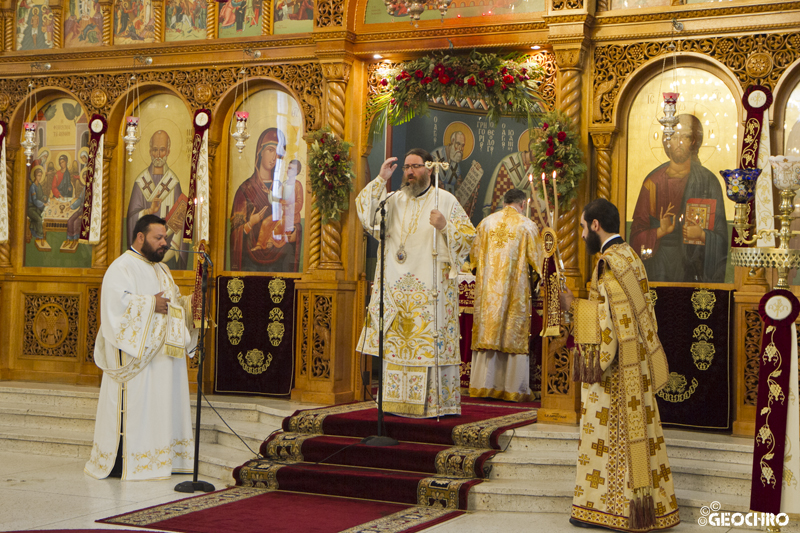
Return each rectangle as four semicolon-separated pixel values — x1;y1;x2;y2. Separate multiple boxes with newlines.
100;401;536;533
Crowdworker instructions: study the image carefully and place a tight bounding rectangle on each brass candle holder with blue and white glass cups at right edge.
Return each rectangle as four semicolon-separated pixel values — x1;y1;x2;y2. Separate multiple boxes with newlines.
720;160;800;290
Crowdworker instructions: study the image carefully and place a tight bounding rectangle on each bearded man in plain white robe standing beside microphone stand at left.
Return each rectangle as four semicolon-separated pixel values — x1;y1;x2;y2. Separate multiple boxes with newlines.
84;215;198;480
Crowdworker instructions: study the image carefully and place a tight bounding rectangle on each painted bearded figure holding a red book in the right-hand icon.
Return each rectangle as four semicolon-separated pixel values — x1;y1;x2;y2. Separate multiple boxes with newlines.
631;115;729;282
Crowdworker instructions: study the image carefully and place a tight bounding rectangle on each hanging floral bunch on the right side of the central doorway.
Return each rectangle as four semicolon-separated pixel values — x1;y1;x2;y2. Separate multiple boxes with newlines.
530;110;587;213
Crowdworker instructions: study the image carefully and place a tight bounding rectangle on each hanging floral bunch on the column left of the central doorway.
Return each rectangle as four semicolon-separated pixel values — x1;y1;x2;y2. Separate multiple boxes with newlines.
306;126;355;224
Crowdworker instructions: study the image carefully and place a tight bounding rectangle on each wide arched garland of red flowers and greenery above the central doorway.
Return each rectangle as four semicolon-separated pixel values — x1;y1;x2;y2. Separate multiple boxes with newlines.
370;50;545;134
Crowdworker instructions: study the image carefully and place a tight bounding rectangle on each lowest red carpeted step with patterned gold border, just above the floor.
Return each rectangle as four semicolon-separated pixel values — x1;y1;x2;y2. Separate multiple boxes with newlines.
233;459;482;509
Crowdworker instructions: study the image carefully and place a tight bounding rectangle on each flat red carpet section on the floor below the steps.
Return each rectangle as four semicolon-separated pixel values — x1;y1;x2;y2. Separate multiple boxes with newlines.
100;487;463;533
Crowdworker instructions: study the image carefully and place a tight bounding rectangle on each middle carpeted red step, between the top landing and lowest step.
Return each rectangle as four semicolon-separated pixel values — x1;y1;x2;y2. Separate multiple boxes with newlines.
260;433;497;478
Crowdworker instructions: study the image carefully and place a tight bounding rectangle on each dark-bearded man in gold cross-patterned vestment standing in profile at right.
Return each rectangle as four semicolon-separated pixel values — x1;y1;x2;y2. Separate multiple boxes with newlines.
561;198;680;532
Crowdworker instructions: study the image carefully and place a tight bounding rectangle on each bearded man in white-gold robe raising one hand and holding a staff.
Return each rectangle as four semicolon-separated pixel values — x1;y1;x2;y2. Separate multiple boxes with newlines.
356;148;475;418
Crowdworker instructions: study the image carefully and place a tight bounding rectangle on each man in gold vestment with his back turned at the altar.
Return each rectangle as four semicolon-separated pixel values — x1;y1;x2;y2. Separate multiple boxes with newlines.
469;189;543;402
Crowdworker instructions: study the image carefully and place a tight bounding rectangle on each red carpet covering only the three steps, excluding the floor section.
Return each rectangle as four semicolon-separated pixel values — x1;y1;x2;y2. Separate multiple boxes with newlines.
233;402;536;509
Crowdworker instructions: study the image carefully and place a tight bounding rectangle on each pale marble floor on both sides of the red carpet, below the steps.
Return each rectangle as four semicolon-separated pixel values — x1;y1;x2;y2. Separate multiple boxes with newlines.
0;452;752;533
